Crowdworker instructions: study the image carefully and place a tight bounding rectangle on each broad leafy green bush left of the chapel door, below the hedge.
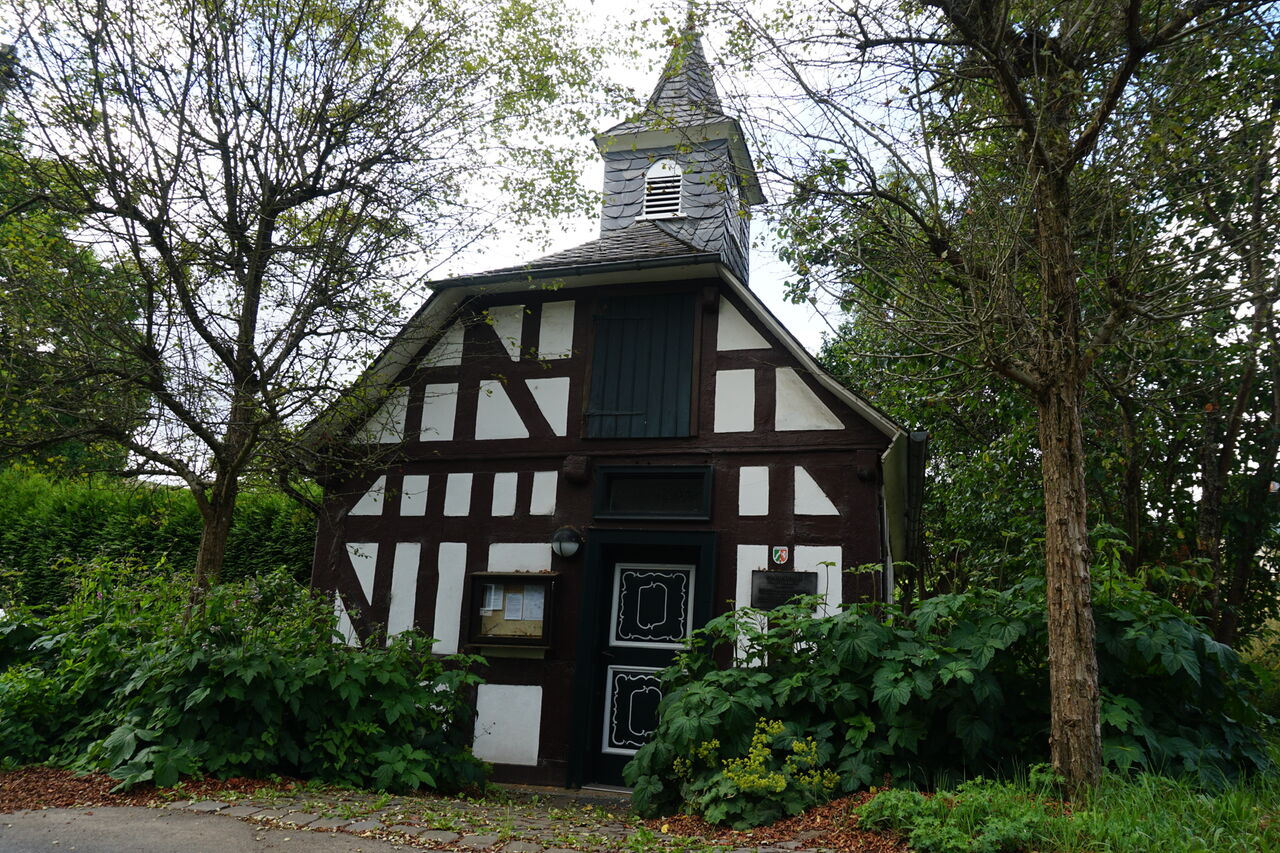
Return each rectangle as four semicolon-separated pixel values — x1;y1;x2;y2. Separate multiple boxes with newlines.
0;566;483;790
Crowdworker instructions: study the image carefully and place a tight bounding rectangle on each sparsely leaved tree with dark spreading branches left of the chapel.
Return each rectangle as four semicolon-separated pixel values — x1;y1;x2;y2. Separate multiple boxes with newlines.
1;0;594;587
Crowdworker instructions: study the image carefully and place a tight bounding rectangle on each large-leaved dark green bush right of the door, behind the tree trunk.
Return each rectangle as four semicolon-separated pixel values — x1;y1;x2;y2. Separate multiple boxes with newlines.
625;580;1268;825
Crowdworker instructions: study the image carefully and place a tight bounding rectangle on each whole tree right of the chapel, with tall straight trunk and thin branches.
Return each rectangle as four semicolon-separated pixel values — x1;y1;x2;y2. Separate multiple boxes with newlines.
717;0;1266;789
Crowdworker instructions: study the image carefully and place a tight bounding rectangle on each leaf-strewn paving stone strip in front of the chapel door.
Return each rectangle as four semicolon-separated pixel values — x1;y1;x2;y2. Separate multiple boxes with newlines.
165;792;820;853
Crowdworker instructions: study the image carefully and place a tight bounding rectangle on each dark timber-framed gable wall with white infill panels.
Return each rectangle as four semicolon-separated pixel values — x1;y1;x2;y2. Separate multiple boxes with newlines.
314;274;887;784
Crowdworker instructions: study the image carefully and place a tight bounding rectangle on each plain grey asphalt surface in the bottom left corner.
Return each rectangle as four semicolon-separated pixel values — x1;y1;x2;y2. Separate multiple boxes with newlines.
0;808;406;853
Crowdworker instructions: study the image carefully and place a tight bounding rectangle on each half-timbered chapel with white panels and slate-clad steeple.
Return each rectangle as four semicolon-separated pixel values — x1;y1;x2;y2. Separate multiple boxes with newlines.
312;33;922;786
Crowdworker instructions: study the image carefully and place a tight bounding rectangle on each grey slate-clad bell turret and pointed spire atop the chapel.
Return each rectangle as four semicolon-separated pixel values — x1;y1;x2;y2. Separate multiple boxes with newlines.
595;19;764;282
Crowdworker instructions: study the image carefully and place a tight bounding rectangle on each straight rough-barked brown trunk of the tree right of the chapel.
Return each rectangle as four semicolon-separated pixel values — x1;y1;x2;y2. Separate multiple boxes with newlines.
1038;380;1102;794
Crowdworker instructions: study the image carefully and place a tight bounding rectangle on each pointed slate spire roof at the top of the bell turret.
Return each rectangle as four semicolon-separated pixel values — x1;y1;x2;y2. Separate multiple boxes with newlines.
603;28;728;136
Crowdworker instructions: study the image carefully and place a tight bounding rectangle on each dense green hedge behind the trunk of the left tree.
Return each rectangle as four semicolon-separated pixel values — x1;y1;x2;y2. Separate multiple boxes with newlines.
0;467;315;611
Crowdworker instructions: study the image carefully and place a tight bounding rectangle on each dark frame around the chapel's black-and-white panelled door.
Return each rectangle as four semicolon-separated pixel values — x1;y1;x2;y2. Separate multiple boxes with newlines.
568;528;719;788
